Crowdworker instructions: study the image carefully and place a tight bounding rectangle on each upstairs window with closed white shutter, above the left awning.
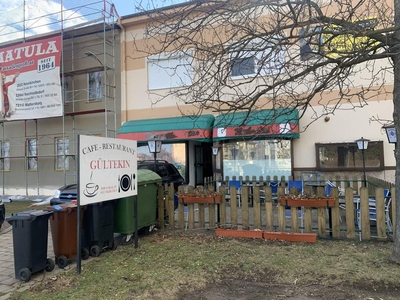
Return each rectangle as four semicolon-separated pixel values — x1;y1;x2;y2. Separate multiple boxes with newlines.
147;51;193;90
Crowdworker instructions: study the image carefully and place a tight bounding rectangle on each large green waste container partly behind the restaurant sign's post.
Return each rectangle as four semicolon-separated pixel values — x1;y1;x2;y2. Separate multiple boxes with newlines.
114;169;162;244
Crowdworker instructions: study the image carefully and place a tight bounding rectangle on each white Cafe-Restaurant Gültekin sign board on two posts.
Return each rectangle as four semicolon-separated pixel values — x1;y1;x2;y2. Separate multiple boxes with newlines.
79;135;137;205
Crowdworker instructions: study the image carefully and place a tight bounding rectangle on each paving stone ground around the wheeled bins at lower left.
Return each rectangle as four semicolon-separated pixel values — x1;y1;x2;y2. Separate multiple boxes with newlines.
0;221;72;300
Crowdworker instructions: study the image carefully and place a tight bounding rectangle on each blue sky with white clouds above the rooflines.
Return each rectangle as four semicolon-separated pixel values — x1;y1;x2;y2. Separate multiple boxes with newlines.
0;0;188;43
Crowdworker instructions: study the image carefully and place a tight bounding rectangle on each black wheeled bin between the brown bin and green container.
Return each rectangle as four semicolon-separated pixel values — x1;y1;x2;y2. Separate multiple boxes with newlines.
83;200;118;257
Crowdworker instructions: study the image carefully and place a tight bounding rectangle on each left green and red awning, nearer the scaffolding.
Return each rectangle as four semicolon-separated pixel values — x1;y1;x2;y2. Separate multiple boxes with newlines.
117;115;215;143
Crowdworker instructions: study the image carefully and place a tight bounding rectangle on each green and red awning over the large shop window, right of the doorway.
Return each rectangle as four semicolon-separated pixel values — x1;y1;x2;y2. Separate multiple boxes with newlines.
213;108;300;141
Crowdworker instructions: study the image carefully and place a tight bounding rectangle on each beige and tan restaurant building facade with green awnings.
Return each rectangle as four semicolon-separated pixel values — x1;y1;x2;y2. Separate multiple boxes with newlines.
118;3;395;189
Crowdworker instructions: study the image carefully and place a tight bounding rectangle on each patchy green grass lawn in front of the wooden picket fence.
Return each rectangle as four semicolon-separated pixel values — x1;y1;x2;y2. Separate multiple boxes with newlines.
8;232;400;300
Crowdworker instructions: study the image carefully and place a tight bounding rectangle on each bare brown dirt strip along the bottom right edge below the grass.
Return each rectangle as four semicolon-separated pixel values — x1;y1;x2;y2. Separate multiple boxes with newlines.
178;278;400;300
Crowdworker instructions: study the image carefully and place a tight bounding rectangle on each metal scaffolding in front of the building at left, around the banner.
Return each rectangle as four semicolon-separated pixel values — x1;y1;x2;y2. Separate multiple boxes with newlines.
0;0;121;196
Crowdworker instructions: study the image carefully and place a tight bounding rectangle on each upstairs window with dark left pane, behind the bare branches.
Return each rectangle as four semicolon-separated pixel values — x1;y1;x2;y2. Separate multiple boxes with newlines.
230;38;285;78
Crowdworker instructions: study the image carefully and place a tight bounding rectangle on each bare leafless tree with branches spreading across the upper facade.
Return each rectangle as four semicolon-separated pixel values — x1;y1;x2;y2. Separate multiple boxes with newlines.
134;0;400;263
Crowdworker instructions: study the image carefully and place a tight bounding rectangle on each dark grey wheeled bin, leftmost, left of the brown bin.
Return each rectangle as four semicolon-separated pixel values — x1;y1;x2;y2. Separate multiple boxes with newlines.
7;210;54;282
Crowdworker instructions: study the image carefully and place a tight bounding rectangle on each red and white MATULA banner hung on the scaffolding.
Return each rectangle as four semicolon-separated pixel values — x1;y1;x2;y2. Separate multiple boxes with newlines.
0;35;63;120
